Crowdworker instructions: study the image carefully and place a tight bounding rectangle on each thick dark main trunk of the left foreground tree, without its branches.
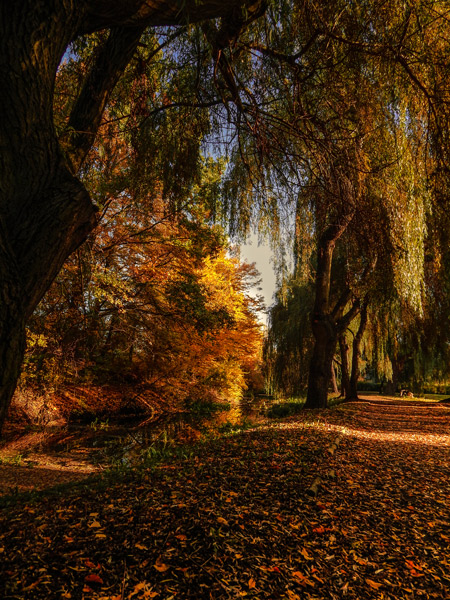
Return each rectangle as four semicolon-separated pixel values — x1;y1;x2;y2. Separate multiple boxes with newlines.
0;2;96;431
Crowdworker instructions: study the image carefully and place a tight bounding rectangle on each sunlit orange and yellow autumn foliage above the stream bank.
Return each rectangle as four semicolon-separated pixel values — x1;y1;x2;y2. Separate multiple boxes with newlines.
23;189;262;412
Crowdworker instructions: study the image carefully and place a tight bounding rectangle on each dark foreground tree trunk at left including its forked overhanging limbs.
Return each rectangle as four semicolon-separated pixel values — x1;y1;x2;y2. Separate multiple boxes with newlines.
0;0;263;431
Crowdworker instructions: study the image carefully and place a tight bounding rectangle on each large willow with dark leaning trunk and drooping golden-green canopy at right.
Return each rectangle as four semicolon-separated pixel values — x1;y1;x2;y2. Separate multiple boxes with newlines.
232;0;449;407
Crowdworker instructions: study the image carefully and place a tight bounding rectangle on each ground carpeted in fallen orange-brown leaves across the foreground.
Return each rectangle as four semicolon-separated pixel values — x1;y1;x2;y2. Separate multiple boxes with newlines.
0;401;450;600
